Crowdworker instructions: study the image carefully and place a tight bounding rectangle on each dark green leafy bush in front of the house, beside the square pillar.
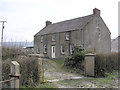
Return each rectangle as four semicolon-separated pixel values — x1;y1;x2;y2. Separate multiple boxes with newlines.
64;45;85;68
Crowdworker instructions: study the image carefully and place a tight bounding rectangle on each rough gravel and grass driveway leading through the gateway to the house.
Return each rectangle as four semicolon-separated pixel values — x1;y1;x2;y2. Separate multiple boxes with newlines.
44;60;118;88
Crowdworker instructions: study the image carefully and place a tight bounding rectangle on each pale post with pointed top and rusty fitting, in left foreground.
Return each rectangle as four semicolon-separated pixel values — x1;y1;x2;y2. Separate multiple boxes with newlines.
11;61;20;88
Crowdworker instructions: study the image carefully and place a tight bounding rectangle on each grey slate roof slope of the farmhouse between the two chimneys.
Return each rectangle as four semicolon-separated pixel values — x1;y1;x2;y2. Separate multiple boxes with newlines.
35;14;93;36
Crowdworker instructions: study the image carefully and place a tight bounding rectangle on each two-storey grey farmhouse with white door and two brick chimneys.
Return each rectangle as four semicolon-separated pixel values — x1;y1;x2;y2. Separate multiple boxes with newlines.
34;8;111;58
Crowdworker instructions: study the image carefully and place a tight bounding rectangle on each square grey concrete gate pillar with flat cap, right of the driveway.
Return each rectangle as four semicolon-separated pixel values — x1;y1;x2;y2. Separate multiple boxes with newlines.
85;53;95;76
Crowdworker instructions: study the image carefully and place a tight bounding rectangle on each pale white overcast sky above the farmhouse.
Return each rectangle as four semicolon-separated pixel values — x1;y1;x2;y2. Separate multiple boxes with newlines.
0;0;119;41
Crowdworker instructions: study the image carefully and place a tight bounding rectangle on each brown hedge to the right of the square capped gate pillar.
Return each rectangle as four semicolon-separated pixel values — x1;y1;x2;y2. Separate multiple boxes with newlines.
95;53;118;76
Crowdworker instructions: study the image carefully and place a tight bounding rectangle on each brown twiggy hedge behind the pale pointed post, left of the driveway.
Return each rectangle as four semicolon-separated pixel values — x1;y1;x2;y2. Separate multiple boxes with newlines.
2;56;39;87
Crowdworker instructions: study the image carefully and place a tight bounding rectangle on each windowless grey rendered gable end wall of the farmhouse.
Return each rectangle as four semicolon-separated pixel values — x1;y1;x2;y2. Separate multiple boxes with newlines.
84;16;111;53
